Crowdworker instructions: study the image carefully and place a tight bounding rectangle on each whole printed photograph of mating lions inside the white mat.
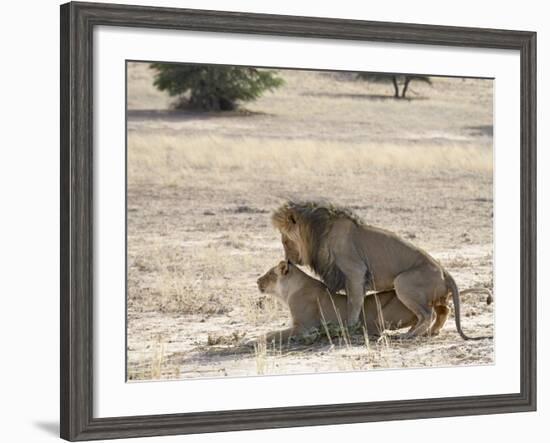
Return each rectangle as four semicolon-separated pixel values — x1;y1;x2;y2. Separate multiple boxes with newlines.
126;61;494;381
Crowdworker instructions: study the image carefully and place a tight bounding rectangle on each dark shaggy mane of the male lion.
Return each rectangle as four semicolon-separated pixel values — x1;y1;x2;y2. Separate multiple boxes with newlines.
280;201;372;294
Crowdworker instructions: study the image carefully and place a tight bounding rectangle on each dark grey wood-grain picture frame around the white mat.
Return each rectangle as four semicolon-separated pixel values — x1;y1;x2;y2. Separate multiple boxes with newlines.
60;3;536;441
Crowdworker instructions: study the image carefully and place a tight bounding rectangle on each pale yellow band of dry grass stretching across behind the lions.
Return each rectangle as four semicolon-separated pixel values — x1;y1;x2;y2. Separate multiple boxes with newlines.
128;134;493;186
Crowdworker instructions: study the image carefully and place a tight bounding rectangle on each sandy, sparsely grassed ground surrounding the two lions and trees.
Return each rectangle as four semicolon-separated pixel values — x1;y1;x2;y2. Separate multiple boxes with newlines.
128;64;498;380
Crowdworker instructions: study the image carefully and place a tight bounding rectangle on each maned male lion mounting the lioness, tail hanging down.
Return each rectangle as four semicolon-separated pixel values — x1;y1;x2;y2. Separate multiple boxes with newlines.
272;201;491;340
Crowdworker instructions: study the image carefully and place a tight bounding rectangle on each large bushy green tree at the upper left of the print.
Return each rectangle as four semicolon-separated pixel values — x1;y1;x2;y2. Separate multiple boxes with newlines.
150;63;283;111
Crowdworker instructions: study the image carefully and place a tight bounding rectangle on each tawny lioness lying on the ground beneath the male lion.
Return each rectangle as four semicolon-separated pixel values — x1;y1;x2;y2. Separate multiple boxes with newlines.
258;261;418;342
